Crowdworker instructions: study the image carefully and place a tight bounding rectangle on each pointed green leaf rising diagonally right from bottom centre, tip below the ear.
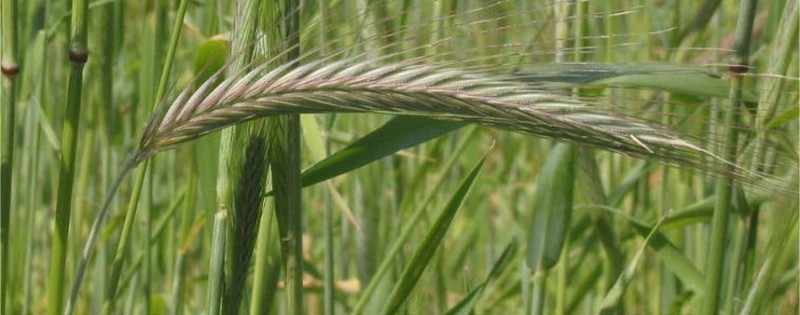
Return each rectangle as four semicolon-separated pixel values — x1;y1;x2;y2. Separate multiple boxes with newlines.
381;156;486;314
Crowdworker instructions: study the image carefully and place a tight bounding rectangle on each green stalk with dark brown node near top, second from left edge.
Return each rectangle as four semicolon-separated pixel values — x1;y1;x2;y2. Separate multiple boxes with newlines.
47;0;89;315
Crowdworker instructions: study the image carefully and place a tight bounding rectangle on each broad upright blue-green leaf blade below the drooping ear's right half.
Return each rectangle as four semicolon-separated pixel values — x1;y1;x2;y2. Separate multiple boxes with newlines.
527;143;575;271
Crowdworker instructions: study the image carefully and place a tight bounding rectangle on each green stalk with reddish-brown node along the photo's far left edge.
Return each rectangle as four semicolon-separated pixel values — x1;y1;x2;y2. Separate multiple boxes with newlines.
0;0;20;312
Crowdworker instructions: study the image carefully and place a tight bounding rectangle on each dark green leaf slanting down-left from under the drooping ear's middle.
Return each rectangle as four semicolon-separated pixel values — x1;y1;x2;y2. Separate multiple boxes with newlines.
302;116;466;187
